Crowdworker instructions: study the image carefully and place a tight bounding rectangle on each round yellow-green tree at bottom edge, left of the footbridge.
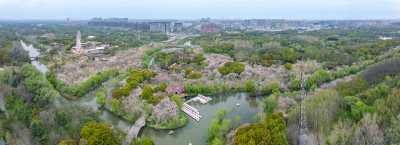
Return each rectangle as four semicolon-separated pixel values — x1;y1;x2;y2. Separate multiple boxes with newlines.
81;122;118;145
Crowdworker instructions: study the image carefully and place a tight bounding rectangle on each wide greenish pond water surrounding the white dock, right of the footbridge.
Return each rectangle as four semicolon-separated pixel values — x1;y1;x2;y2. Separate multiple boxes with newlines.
139;93;264;145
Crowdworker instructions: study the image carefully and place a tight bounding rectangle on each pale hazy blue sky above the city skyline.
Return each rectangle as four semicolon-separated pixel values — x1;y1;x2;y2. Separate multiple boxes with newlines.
0;0;400;20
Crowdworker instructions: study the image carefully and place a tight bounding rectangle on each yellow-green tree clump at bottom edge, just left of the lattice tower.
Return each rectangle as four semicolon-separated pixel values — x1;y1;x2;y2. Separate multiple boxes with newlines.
233;112;289;145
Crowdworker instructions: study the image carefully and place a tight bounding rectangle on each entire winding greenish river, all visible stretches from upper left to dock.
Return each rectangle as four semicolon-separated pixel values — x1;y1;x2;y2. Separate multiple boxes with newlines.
21;41;264;145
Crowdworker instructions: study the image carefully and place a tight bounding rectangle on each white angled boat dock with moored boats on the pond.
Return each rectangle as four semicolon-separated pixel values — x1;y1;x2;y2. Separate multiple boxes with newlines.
181;94;212;121
